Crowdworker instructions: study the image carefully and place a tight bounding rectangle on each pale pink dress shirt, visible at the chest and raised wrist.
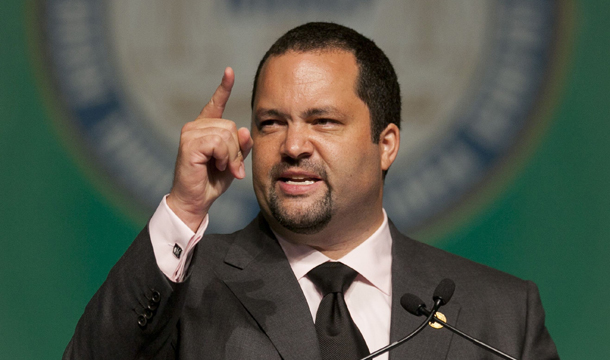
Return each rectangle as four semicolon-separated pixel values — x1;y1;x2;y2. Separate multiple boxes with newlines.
148;197;392;360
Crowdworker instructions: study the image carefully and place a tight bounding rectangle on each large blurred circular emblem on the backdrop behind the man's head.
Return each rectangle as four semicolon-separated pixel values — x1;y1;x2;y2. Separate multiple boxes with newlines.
35;0;558;232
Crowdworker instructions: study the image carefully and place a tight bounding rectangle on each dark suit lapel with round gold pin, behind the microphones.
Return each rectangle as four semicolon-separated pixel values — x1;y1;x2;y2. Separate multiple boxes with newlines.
390;222;460;360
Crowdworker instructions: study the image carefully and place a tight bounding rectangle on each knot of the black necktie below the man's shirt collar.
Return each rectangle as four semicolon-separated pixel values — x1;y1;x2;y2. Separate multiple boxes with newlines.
307;262;358;296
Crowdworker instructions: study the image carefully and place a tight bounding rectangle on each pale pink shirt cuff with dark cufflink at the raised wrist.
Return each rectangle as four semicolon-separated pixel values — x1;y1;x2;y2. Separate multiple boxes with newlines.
148;195;209;282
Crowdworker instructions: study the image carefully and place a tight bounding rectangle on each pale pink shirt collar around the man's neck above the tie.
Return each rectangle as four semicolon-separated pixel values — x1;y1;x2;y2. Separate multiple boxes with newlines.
274;210;392;296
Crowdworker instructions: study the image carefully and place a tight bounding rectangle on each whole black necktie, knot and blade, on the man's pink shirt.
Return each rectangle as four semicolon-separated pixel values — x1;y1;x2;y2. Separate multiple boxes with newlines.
307;262;369;360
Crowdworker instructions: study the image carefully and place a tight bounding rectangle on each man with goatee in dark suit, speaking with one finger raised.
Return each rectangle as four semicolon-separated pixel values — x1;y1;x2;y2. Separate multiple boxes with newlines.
64;23;558;360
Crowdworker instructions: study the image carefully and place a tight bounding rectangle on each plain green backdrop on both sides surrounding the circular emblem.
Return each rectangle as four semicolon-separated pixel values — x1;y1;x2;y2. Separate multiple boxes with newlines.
0;0;610;359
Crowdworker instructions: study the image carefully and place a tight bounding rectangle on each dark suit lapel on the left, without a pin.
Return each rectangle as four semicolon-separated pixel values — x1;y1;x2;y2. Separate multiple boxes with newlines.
218;216;320;360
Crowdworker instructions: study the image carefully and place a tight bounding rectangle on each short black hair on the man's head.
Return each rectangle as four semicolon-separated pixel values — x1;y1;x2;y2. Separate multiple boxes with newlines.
250;22;401;144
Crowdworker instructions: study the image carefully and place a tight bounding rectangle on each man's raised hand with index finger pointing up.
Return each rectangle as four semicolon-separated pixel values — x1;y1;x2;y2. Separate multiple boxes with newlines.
167;68;252;231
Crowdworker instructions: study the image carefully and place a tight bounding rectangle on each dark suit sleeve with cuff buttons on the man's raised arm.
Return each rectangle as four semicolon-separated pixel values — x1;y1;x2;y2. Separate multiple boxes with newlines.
63;226;189;359
